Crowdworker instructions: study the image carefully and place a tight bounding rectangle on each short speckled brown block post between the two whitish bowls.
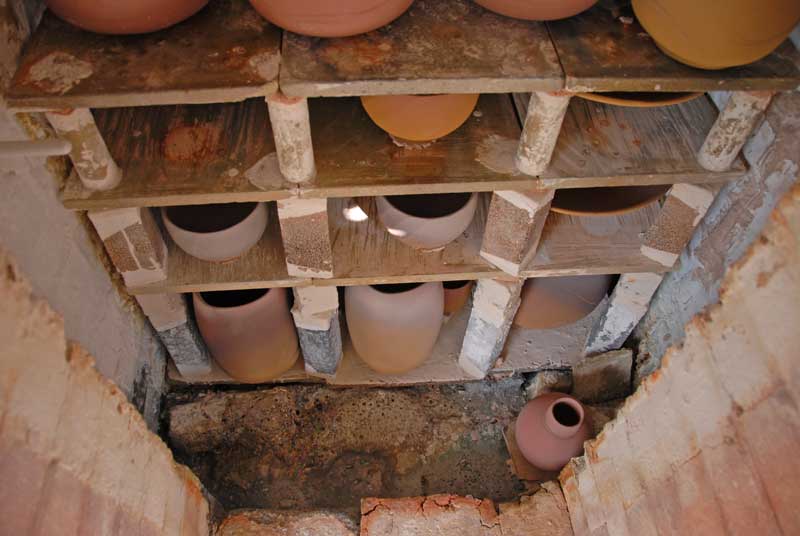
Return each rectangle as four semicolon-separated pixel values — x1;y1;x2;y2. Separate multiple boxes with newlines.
278;199;333;279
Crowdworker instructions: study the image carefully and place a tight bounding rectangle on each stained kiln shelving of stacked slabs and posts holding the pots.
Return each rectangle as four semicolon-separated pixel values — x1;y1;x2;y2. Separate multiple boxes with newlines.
7;0;800;385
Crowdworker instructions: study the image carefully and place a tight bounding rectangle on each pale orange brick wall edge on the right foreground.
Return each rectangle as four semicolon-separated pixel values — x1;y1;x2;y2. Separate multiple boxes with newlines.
560;187;800;536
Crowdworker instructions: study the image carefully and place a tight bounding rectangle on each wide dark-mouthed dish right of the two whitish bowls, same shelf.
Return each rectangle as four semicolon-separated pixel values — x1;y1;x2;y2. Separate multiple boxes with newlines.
550;185;670;216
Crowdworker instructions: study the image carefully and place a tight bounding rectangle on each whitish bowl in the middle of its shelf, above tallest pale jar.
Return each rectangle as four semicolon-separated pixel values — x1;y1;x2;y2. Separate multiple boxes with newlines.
375;193;478;250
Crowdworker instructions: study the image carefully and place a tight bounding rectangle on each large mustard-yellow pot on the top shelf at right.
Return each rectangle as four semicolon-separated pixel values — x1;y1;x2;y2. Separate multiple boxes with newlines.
633;0;800;69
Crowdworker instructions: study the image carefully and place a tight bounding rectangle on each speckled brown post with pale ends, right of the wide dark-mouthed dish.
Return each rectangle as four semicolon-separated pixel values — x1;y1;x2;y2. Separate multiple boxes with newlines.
641;183;719;268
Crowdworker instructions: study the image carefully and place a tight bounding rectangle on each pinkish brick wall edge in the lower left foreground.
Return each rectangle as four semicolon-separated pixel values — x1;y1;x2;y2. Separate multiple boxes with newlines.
0;249;209;536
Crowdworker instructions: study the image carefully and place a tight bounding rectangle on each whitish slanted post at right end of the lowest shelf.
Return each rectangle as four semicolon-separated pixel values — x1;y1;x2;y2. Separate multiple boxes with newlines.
584;273;664;356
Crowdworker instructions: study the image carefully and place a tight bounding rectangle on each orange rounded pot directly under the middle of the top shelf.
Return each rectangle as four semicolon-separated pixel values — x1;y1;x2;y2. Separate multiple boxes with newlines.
361;94;479;142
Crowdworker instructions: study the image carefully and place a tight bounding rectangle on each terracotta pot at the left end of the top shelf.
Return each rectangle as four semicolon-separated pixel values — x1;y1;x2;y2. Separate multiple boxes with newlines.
46;0;208;34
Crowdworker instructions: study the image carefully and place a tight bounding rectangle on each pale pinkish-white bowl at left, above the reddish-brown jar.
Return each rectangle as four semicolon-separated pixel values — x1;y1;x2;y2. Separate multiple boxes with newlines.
161;203;267;262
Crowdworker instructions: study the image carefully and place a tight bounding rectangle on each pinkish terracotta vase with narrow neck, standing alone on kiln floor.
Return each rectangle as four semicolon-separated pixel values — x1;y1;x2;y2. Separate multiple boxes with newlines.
514;393;591;471
